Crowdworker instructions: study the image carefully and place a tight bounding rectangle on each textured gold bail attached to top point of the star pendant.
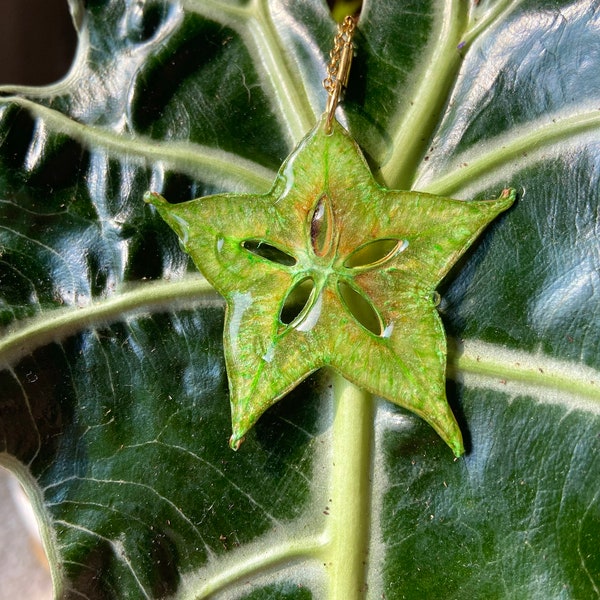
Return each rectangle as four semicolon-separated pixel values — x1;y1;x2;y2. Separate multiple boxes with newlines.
323;17;356;133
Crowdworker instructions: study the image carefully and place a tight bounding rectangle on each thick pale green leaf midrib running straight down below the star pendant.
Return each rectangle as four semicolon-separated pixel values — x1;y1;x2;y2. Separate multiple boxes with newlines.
326;374;375;600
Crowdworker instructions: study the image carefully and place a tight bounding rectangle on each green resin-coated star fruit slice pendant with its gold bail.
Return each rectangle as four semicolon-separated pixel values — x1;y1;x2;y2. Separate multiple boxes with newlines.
145;18;515;456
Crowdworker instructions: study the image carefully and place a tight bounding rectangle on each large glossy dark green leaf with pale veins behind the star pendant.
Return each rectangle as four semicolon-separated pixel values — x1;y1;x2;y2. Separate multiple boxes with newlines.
0;0;600;600
